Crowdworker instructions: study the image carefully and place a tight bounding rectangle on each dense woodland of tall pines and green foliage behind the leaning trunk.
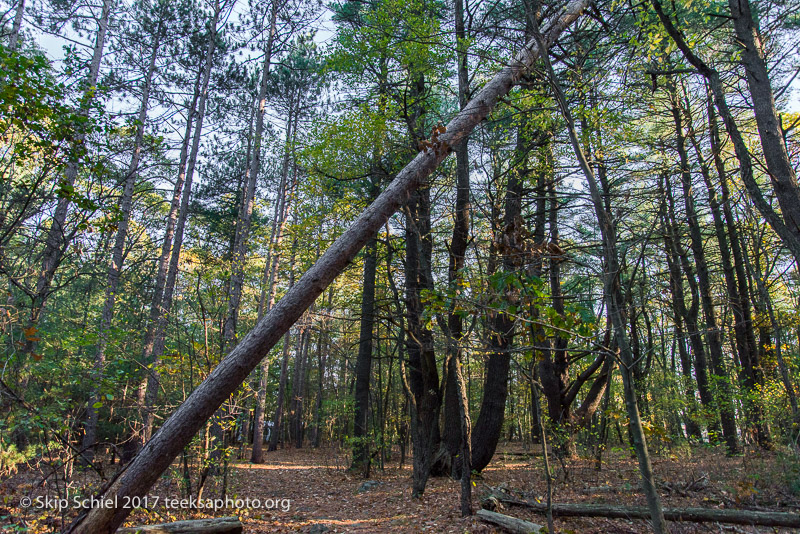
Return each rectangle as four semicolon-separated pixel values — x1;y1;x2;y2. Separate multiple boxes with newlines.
0;0;800;532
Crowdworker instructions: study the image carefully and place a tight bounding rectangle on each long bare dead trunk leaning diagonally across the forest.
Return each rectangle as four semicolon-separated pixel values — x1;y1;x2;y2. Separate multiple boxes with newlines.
66;0;589;534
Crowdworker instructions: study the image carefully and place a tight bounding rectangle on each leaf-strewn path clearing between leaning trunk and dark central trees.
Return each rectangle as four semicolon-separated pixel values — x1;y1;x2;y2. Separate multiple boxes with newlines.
222;450;494;533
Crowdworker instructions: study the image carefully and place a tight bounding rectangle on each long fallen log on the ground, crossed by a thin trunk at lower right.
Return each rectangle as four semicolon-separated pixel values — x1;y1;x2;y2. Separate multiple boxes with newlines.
493;493;800;528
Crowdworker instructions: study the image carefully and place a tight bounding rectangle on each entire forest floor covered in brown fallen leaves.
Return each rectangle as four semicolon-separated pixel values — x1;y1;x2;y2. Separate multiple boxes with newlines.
0;447;800;534
